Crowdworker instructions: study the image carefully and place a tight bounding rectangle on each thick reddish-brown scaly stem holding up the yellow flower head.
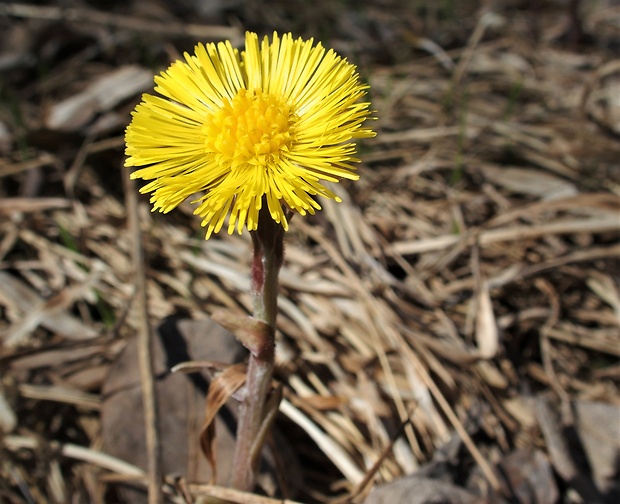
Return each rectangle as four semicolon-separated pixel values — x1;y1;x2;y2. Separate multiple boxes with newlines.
231;208;284;491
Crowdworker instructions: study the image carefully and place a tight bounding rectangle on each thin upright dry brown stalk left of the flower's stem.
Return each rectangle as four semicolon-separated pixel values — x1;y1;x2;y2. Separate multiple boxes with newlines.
122;169;163;504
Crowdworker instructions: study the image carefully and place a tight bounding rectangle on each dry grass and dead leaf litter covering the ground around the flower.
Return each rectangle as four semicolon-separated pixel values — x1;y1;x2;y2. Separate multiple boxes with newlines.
0;0;620;504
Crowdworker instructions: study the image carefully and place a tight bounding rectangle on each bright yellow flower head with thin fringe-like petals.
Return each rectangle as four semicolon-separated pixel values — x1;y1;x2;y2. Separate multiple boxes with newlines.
125;32;374;238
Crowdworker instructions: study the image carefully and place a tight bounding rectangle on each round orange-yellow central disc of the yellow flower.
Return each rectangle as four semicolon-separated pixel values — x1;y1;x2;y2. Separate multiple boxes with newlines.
202;89;295;168
